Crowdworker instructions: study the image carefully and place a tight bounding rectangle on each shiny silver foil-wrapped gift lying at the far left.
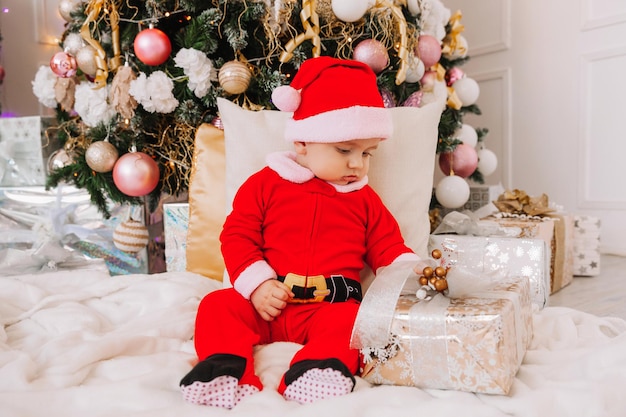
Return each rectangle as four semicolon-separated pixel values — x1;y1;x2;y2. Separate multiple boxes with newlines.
0;186;147;275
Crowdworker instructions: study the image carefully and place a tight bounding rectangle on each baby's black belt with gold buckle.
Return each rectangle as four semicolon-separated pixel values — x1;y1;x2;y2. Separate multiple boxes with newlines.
277;274;363;303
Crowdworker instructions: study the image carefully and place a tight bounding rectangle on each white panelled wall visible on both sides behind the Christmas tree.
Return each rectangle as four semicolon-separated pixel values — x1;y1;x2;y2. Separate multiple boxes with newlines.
0;0;626;254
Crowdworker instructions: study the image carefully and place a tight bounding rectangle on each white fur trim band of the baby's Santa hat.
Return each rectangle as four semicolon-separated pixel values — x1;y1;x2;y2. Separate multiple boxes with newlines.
285;106;393;143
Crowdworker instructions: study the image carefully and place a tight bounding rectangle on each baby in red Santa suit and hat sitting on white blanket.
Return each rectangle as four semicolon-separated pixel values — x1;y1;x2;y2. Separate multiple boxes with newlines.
181;57;423;408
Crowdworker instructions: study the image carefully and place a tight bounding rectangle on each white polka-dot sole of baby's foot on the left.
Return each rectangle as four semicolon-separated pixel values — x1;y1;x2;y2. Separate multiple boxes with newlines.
181;375;259;409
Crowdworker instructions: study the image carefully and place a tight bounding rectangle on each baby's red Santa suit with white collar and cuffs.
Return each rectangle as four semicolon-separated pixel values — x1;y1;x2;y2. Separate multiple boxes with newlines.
194;152;419;392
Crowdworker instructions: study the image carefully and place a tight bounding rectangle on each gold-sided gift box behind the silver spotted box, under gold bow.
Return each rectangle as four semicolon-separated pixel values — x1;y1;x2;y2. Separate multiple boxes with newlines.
486;213;574;294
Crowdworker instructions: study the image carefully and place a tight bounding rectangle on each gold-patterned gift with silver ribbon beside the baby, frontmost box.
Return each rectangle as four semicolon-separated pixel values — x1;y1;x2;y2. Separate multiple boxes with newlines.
352;265;532;394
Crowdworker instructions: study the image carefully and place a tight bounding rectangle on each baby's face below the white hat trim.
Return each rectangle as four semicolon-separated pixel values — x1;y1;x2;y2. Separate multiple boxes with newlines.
295;138;381;185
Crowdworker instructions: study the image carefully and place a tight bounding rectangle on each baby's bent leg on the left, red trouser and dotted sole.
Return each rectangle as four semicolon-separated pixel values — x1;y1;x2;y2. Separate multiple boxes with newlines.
180;288;269;408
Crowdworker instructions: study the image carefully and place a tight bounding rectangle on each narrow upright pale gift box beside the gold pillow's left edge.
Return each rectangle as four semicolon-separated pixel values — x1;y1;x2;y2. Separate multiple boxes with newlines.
163;203;189;271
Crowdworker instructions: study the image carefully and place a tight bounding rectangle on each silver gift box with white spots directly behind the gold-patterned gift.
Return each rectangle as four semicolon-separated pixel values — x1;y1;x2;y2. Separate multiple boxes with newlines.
428;235;550;309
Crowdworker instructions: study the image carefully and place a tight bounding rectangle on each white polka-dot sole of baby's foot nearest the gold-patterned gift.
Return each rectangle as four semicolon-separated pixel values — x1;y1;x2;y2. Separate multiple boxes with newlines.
283;368;354;404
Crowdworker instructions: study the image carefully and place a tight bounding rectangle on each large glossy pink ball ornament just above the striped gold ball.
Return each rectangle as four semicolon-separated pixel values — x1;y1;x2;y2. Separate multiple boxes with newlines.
113;152;159;197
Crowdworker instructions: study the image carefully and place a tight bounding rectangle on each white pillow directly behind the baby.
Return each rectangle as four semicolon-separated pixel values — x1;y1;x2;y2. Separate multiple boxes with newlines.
217;97;445;257
